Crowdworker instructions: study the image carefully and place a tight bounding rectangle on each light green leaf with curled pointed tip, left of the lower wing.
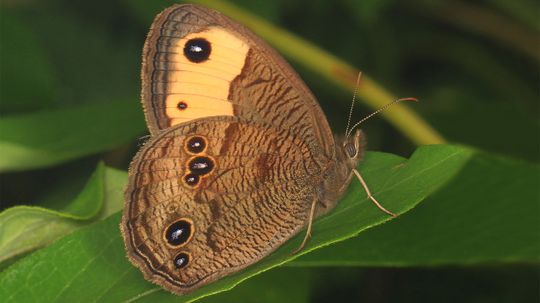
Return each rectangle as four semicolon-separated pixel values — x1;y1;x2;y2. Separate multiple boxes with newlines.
0;164;127;263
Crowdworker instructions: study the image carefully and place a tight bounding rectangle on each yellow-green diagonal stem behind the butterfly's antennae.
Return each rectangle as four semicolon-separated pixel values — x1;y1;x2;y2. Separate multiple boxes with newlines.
194;0;445;145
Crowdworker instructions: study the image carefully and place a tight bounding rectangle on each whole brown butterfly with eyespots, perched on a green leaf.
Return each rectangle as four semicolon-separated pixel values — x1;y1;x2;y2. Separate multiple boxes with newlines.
121;5;398;294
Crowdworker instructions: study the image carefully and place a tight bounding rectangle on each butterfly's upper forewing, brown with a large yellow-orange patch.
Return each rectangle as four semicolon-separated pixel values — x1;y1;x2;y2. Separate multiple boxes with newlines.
142;5;335;159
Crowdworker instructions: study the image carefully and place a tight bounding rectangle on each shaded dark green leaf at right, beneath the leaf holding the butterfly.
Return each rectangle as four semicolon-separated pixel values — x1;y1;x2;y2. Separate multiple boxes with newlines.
292;153;540;266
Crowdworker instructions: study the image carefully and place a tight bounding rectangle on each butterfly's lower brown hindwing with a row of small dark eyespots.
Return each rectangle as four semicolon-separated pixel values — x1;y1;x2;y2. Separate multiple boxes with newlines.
121;116;323;294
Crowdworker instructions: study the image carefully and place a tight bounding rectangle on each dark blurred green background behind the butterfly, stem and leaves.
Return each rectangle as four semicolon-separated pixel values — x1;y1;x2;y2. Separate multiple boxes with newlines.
0;0;540;302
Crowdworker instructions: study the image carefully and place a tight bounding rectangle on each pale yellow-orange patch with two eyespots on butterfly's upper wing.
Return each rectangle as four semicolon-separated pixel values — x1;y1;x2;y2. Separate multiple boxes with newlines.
165;27;249;126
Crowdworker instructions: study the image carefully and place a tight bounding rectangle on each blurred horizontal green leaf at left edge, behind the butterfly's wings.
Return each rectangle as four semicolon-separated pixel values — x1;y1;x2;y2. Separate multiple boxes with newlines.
0;100;145;172
